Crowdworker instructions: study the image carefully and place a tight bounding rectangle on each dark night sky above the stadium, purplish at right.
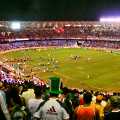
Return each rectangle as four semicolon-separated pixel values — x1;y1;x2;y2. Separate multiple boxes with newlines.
0;0;120;20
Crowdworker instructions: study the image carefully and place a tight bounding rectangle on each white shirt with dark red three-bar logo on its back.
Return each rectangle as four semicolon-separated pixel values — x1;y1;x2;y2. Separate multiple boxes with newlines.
34;98;69;120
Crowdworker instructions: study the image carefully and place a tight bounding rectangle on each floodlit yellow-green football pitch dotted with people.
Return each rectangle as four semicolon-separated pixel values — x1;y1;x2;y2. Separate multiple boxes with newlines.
0;48;120;91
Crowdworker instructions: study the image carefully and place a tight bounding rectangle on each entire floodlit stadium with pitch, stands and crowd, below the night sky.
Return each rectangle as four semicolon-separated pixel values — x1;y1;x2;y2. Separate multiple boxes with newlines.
0;18;120;120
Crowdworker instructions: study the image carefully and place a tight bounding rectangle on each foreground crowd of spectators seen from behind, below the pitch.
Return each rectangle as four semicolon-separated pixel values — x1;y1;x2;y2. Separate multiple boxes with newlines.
0;69;120;120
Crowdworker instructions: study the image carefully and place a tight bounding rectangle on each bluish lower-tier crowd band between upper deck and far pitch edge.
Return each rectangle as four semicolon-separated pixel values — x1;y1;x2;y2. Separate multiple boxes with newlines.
0;39;120;51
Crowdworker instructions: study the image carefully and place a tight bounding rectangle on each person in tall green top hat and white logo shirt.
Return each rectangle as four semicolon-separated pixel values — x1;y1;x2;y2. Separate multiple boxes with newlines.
34;77;69;120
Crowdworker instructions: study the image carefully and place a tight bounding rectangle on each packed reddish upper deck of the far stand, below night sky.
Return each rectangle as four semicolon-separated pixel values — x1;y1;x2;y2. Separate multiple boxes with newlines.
0;21;120;40
